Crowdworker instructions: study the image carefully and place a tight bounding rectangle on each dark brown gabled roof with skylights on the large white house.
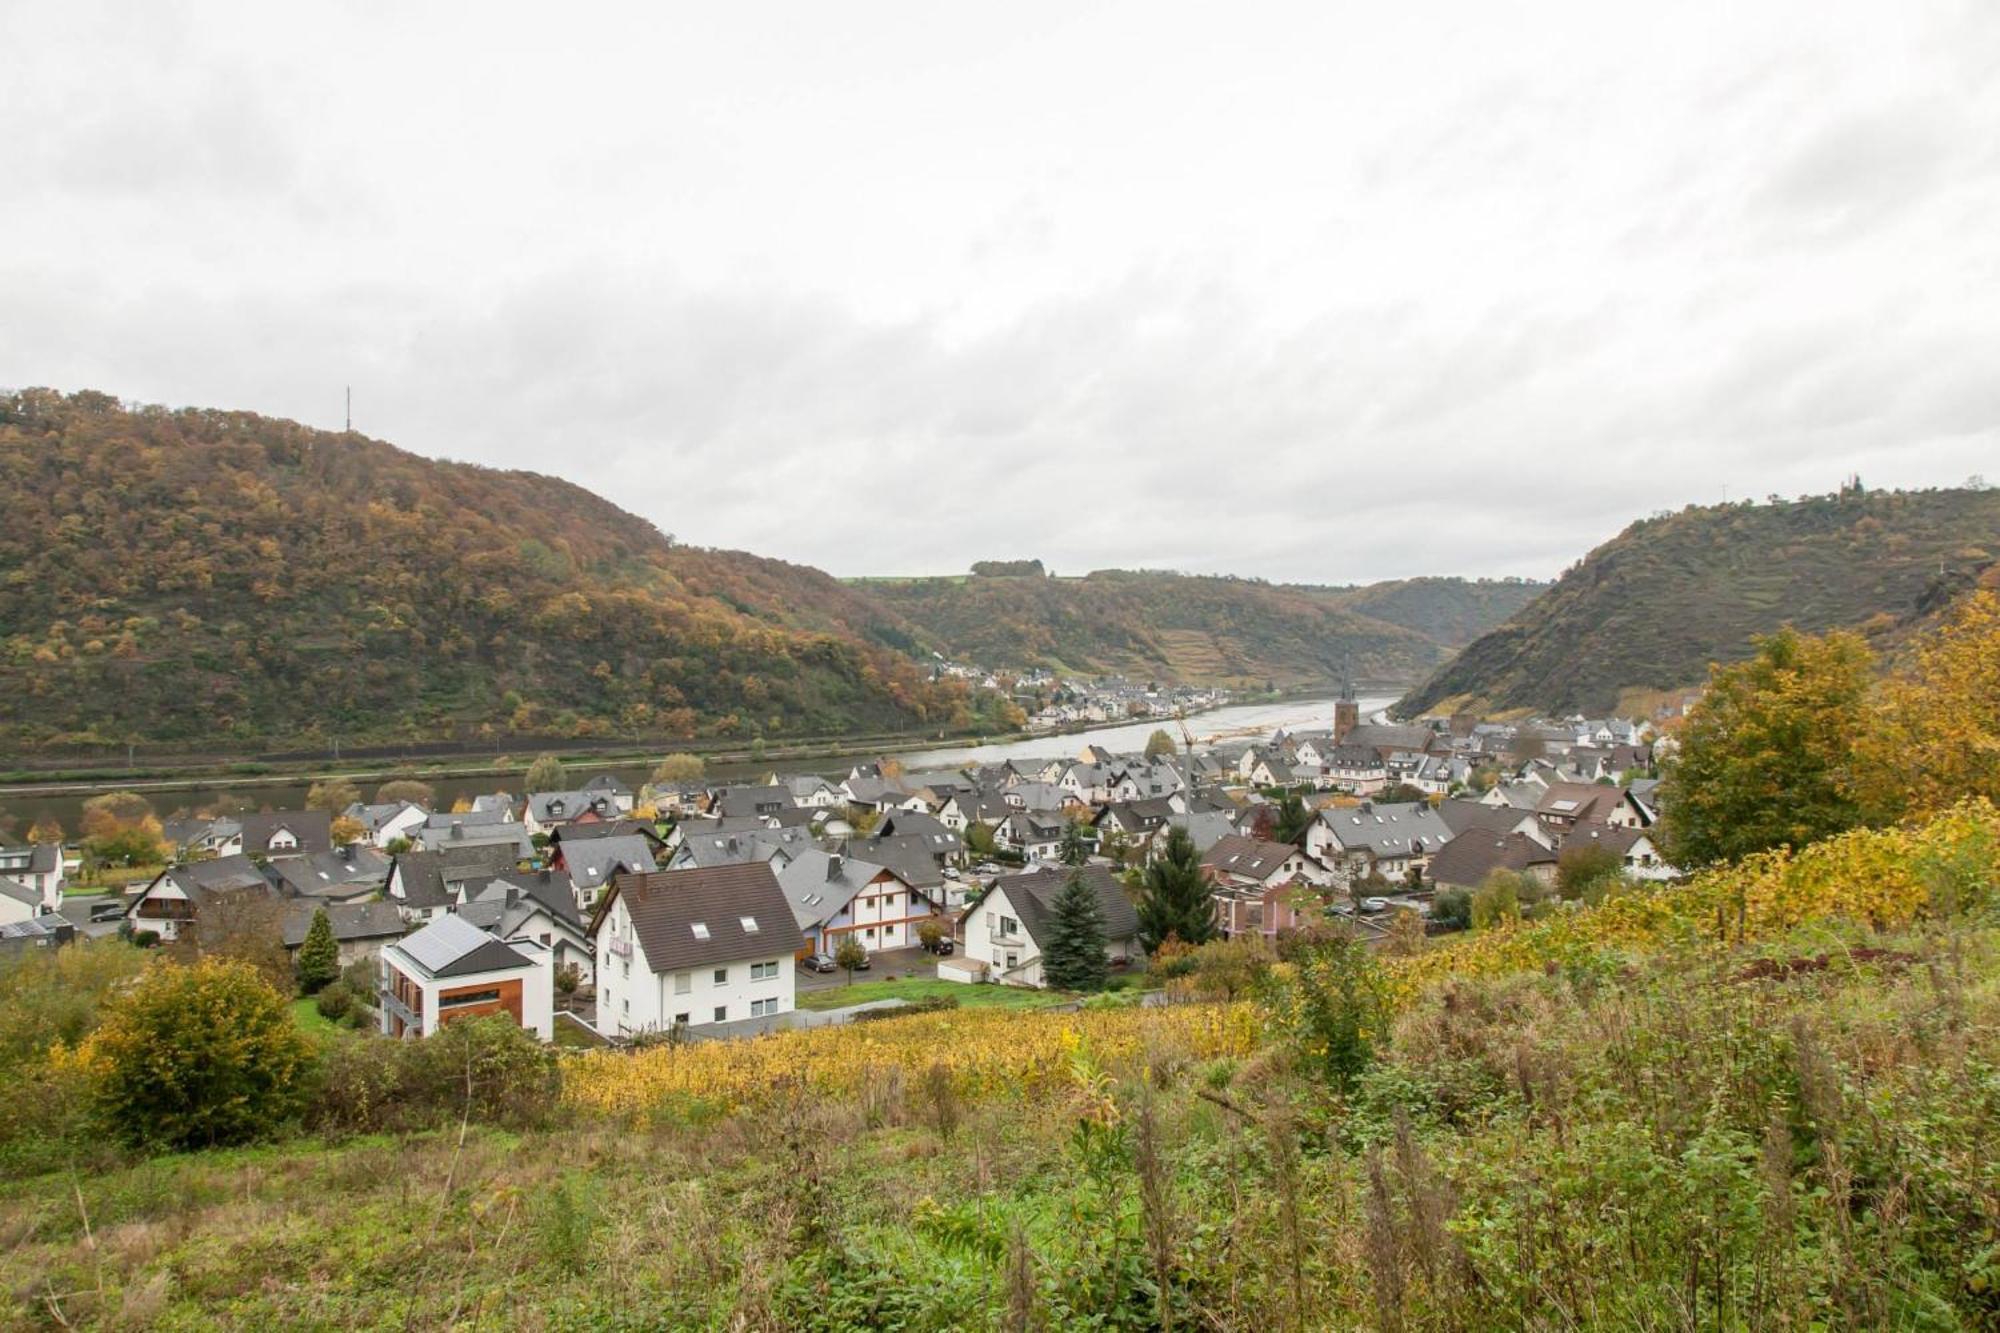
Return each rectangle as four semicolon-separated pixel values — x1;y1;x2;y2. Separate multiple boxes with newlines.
590;861;806;973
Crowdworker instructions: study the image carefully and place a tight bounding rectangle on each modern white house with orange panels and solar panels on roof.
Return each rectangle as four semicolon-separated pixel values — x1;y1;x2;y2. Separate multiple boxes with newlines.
376;917;556;1041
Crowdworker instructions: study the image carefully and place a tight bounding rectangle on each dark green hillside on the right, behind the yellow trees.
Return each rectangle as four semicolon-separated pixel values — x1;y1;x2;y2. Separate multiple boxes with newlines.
1398;490;2000;715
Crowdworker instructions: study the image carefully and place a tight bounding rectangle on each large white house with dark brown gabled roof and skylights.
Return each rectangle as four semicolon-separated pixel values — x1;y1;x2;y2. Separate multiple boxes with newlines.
590;861;806;1039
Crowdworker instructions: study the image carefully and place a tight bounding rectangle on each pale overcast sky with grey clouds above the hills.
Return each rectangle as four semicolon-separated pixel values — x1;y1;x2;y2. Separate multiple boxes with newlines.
0;0;2000;582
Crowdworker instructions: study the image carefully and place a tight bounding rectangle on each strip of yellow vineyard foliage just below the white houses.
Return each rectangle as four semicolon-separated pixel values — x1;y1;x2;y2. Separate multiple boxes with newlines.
562;992;1256;1117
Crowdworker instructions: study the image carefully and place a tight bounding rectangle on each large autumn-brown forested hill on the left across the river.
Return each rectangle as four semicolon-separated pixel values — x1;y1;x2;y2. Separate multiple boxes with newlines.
0;390;970;747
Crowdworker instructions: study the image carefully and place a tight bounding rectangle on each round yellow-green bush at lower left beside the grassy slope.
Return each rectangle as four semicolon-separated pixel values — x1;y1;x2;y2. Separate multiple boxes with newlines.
84;959;312;1149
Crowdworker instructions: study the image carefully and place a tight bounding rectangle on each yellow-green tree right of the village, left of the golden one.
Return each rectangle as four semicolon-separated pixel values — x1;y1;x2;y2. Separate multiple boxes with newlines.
1660;626;1874;869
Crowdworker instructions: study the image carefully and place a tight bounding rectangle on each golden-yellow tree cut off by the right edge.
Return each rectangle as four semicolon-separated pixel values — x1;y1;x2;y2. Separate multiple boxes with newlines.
1848;590;2000;820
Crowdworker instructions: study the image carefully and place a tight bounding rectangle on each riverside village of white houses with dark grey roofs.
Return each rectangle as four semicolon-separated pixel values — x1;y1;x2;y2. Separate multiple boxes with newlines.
0;683;1676;1045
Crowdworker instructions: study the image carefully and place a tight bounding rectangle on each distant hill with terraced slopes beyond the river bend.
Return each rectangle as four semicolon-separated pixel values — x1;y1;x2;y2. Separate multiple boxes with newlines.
860;570;1542;685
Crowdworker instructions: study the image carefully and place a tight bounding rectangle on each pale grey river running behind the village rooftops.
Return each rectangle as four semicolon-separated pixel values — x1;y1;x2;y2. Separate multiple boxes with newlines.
0;695;1394;824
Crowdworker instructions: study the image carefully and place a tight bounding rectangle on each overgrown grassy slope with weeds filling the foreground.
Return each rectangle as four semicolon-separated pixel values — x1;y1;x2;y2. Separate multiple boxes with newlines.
0;925;2000;1333
